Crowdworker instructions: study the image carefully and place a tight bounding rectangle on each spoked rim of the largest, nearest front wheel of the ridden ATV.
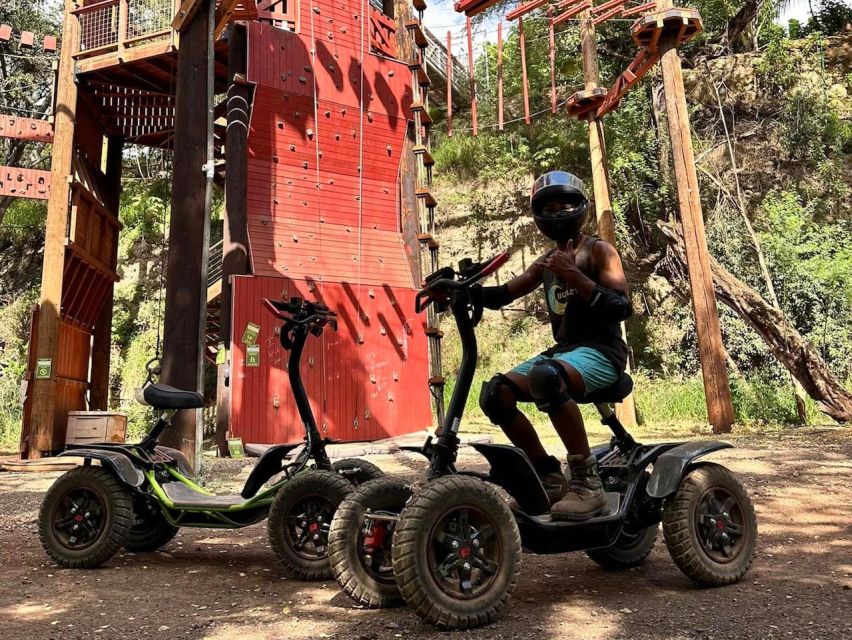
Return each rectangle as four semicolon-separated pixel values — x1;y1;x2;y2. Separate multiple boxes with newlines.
428;506;503;600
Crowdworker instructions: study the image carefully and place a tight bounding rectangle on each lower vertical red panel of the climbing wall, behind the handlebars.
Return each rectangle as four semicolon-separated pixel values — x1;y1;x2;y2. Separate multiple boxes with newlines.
231;277;430;443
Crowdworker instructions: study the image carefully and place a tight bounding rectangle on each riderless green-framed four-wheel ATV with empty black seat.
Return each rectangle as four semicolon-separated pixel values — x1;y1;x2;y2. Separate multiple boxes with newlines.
39;298;383;579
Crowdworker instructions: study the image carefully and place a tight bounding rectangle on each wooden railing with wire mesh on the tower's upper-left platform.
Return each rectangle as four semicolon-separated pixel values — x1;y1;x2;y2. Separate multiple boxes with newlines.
74;0;177;58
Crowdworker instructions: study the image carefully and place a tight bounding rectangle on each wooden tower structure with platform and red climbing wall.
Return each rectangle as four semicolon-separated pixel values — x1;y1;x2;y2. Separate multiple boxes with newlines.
23;0;454;457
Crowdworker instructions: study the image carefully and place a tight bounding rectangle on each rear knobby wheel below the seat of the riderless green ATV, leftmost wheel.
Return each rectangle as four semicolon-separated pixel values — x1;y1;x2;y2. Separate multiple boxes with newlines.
38;466;133;569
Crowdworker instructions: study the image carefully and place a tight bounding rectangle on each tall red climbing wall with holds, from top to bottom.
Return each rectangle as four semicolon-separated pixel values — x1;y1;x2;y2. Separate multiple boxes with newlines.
231;16;431;443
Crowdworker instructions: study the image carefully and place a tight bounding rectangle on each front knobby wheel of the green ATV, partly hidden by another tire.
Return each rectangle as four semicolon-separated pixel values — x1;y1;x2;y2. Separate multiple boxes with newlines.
267;471;352;580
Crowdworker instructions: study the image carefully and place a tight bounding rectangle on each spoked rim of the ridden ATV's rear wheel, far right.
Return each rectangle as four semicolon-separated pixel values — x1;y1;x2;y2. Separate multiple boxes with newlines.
695;487;746;564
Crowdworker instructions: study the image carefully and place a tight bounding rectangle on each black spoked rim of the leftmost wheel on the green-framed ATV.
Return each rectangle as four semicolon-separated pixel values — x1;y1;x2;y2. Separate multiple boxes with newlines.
51;487;106;551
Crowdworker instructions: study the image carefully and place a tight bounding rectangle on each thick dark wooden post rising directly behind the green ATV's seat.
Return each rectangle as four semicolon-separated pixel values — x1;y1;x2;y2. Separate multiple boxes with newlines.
161;0;215;463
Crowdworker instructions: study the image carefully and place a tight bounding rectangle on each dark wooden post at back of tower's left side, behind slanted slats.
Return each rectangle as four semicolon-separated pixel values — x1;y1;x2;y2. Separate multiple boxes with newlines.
89;136;124;411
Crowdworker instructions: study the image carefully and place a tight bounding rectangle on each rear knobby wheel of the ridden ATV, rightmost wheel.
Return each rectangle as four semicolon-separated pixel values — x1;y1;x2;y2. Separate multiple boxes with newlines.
663;463;757;587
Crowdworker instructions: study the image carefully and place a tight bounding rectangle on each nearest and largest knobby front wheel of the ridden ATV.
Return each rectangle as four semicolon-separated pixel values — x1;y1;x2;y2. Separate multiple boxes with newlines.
393;475;521;629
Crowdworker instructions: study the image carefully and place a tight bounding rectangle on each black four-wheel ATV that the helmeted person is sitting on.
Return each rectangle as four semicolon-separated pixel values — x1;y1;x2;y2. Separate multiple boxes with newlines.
329;254;757;628
